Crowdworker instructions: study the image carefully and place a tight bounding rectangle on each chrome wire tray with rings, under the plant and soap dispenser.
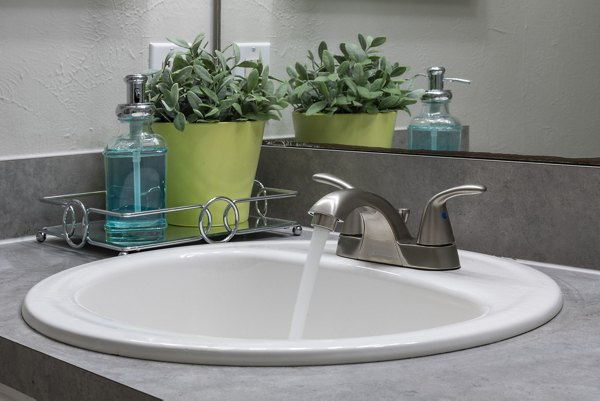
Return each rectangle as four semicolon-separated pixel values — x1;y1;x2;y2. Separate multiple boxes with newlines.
36;181;302;254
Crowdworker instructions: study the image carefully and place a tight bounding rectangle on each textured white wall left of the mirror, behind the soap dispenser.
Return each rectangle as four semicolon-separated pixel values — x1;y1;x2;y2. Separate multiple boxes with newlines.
0;0;212;158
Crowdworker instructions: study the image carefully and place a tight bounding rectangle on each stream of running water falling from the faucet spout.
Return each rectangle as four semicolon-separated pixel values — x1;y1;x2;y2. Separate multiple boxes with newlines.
289;226;330;340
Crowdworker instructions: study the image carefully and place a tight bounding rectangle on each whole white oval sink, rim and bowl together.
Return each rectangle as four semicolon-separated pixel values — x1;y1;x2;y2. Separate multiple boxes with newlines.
22;240;562;366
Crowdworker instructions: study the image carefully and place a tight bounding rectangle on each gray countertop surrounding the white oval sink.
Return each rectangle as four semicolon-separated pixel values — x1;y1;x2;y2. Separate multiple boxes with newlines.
0;234;600;401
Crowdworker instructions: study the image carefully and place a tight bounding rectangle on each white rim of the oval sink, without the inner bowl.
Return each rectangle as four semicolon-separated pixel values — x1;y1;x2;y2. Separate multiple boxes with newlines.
22;240;562;366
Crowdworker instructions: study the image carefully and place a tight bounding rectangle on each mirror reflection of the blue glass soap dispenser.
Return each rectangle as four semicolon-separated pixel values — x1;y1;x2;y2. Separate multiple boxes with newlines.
408;67;471;150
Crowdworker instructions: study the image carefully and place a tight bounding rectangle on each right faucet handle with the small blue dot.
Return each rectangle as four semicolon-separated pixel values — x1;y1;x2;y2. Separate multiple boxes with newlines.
417;185;487;246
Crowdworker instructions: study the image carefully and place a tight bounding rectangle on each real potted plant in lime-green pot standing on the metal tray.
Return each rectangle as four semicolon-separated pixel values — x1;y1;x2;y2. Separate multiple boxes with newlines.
146;34;287;226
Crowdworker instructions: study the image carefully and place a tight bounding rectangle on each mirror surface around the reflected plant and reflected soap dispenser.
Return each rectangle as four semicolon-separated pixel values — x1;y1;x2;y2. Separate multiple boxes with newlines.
222;0;600;164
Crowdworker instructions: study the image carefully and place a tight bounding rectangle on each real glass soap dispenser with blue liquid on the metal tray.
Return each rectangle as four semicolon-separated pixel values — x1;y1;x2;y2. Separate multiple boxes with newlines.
103;74;167;245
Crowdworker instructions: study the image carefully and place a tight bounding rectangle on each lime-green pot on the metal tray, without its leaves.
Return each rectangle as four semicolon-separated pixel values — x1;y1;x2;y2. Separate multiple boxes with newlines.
152;121;265;227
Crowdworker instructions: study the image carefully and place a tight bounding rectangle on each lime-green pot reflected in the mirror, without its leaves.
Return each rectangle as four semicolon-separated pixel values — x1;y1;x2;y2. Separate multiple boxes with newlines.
292;112;396;148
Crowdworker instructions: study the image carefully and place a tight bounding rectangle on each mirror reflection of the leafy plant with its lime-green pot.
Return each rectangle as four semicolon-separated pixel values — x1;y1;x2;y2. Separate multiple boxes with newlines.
287;34;416;147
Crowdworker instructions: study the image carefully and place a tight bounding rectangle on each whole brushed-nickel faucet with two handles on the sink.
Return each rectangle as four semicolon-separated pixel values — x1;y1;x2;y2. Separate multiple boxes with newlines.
308;173;486;270
